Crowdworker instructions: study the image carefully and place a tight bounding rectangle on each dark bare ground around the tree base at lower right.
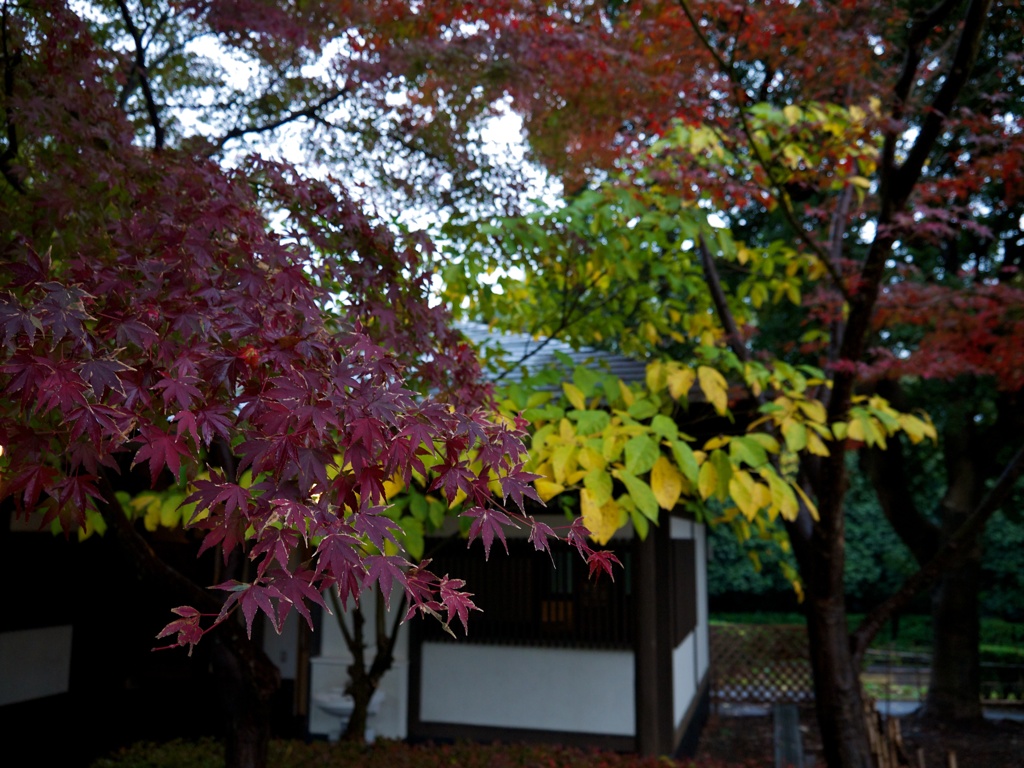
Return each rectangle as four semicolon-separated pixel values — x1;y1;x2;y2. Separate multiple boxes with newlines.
697;708;1024;768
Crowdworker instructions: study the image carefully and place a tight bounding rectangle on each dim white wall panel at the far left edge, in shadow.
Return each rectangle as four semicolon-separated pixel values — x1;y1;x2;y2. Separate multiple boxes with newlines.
0;624;72;705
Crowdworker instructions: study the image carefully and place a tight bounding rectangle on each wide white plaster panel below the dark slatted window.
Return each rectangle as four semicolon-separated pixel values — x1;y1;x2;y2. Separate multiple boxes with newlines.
420;643;636;736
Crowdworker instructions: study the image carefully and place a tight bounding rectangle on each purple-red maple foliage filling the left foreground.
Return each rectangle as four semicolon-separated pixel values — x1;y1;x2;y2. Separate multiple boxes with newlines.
0;2;622;645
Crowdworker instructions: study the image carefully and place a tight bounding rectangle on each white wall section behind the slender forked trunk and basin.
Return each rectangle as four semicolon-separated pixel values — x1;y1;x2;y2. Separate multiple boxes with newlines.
309;593;409;738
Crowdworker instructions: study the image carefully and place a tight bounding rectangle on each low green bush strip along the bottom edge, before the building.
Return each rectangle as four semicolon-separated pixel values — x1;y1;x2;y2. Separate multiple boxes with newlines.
91;739;742;768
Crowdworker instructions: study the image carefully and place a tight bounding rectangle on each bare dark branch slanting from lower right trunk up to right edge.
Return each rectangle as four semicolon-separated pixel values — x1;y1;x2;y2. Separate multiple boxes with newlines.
850;445;1024;667
